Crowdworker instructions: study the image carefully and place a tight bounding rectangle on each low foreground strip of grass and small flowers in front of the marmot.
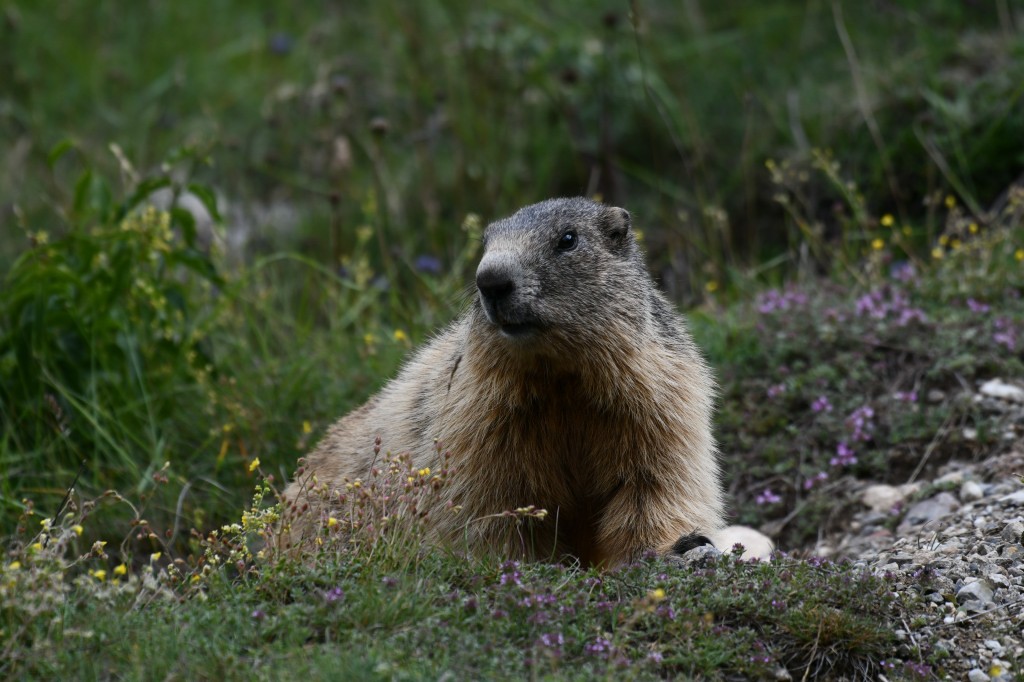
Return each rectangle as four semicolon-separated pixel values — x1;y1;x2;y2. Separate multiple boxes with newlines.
0;488;915;679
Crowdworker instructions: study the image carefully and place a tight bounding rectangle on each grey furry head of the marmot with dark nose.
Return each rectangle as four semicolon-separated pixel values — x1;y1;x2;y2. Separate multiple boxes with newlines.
476;199;651;350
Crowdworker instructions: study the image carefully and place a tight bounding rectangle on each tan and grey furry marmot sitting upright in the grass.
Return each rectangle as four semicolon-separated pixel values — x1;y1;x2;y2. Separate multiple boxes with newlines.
285;198;741;566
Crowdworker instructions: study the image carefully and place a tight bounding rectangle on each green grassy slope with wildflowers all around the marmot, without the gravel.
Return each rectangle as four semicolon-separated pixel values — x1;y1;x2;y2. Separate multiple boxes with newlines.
0;0;1024;679
